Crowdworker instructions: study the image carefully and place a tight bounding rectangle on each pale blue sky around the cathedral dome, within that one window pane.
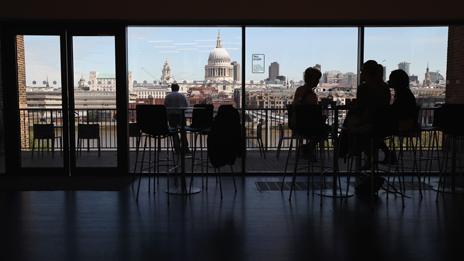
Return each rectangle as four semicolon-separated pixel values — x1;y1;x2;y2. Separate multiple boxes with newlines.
128;27;242;81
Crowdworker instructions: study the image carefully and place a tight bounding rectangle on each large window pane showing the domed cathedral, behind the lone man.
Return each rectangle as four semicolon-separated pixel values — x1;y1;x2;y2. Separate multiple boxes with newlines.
128;27;242;172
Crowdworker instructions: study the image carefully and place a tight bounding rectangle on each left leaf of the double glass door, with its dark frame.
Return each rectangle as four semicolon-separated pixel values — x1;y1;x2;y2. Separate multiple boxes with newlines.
2;27;69;175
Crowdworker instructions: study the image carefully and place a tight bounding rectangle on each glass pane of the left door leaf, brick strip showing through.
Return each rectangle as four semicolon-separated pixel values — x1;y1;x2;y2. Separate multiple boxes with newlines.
16;35;63;167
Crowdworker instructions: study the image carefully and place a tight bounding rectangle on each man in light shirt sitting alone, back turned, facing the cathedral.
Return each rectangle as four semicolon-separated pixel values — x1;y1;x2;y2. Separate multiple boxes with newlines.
164;83;190;153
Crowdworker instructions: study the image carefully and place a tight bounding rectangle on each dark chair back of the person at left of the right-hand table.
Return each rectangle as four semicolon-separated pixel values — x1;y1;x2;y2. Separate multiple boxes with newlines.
292;105;325;138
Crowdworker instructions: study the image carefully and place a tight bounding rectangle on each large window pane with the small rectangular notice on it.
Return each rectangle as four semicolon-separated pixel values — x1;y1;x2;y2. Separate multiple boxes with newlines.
245;27;358;172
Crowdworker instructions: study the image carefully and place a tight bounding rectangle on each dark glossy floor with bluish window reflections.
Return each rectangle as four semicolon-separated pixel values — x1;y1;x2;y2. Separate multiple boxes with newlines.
0;177;464;261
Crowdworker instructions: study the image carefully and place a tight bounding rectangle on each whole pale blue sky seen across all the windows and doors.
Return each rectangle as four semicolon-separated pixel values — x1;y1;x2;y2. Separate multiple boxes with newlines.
25;27;448;85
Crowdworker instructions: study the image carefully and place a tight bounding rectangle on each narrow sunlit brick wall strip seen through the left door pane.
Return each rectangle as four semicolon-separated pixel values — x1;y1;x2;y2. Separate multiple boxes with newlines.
16;35;29;148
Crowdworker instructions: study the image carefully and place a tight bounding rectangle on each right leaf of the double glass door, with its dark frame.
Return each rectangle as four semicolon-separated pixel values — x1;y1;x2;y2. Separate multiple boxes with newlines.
67;29;128;175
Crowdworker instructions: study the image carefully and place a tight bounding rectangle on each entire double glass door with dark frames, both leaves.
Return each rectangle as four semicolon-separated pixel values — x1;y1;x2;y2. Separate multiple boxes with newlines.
1;26;128;175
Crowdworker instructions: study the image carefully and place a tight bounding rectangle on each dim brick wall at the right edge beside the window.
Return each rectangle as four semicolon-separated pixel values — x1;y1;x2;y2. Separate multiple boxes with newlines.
446;26;464;103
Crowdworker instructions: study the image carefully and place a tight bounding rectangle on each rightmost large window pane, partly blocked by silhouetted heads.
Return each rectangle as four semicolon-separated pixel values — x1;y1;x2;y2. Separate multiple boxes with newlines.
364;27;448;107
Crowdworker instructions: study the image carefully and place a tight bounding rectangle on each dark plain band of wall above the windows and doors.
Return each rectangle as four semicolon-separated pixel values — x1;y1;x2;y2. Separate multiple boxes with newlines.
0;0;464;24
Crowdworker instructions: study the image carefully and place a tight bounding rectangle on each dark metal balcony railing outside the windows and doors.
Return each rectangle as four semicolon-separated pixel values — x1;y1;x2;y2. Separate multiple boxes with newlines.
20;107;441;151
